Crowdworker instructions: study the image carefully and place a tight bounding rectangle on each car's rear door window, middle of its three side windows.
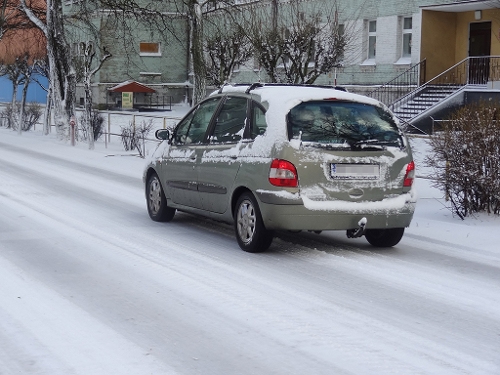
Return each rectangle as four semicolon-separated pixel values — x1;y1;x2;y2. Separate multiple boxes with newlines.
210;96;248;143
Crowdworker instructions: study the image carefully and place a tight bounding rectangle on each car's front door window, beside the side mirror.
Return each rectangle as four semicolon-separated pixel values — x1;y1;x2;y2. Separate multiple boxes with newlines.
174;98;220;145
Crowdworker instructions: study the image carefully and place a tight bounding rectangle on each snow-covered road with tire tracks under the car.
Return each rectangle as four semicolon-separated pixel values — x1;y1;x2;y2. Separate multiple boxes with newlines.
0;129;500;375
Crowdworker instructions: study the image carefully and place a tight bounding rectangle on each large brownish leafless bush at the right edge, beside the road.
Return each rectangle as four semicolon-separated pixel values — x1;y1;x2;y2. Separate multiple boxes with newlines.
426;102;500;219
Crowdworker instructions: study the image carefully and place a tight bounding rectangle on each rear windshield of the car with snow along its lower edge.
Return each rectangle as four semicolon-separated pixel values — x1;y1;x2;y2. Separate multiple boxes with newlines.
287;101;401;147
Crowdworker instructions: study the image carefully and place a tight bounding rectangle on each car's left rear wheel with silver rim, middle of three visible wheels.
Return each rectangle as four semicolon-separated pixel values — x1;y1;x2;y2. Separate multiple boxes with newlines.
234;193;273;253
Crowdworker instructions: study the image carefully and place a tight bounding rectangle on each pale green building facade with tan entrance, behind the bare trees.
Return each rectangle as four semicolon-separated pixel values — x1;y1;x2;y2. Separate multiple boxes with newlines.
62;0;500;113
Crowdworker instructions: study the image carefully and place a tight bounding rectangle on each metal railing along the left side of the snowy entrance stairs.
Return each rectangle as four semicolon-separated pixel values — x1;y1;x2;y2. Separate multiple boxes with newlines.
368;59;426;106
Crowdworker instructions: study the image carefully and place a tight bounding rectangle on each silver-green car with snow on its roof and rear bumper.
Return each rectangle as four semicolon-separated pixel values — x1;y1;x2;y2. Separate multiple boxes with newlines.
143;83;416;252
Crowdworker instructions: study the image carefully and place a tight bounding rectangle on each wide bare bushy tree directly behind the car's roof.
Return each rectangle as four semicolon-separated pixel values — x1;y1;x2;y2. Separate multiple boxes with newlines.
248;0;349;84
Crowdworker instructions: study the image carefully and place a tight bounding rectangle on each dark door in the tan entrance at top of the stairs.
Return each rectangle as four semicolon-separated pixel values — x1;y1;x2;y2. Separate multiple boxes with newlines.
467;22;491;85
